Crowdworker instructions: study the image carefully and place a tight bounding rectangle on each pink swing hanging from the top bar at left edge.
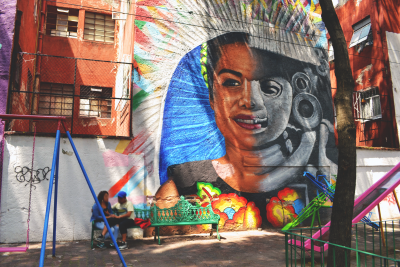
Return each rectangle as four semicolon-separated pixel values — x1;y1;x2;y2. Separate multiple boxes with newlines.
0;118;36;252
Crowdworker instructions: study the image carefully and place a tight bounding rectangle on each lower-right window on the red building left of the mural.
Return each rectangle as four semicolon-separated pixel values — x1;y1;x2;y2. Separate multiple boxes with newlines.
79;86;112;118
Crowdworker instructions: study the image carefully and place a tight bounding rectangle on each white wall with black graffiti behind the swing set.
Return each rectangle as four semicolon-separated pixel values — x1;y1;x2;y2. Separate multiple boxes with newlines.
0;136;159;243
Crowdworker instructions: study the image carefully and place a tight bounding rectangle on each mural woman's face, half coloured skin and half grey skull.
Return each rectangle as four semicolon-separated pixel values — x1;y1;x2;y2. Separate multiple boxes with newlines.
210;43;292;150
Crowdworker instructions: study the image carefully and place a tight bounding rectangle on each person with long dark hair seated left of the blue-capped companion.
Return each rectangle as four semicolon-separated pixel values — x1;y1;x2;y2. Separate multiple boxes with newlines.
90;191;119;248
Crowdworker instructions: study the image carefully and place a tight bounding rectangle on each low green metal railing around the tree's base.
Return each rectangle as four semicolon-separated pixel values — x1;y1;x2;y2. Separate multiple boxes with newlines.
283;220;400;267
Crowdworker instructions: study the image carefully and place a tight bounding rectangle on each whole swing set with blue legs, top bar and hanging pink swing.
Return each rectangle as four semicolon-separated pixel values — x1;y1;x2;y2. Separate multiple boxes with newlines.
0;114;126;267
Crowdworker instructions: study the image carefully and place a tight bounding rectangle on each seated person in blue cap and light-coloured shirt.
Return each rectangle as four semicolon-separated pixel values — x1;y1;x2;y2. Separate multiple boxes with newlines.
112;191;135;250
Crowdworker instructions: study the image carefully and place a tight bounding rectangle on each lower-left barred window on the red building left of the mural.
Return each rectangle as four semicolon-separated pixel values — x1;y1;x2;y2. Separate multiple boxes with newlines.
39;83;74;116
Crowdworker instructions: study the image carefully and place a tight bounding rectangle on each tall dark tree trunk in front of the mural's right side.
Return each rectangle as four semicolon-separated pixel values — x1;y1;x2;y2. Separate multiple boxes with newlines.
319;0;356;266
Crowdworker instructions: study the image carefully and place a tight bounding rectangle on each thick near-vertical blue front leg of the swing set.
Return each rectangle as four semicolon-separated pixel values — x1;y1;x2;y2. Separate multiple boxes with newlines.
39;130;60;267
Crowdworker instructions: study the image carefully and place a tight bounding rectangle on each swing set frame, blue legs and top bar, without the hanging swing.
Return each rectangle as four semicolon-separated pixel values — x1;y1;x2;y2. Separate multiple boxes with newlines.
0;114;126;267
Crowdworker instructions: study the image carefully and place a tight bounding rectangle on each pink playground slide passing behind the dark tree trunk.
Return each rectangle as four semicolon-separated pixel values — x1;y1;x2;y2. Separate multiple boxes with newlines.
289;163;400;252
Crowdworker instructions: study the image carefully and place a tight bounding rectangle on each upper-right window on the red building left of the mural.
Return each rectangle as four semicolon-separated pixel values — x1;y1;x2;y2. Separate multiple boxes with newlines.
83;12;115;43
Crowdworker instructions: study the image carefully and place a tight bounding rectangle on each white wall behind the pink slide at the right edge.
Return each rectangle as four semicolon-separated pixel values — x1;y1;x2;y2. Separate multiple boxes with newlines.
355;149;400;220
